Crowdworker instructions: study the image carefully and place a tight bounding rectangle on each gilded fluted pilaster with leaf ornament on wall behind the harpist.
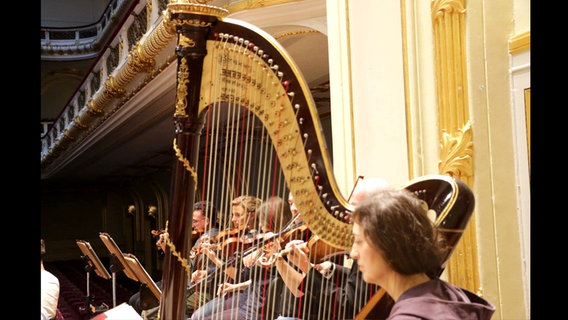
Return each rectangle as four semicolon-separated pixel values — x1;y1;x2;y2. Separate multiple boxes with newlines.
431;0;481;294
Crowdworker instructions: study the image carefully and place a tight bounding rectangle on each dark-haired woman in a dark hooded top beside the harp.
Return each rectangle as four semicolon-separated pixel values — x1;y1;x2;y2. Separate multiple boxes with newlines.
350;189;495;320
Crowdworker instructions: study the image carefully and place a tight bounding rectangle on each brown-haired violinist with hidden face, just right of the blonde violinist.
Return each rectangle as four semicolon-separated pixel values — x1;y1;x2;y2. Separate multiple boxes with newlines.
191;197;292;320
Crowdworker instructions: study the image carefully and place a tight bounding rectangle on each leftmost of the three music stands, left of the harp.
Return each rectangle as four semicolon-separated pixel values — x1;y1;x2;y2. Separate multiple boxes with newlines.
75;240;111;314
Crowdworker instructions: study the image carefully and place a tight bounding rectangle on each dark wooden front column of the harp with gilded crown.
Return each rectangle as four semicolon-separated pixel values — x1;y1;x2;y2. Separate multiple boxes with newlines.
160;0;227;320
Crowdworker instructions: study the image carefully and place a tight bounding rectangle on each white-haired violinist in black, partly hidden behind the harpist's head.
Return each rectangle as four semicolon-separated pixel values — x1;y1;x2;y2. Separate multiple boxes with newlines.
276;178;393;320
